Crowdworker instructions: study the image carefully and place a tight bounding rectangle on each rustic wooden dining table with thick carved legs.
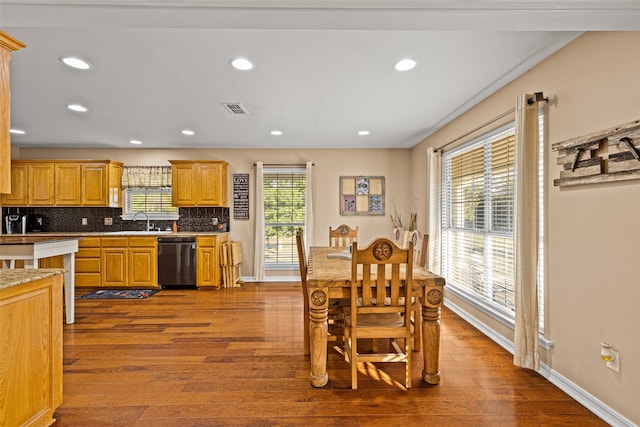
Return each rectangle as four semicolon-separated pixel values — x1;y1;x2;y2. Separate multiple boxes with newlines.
307;246;445;387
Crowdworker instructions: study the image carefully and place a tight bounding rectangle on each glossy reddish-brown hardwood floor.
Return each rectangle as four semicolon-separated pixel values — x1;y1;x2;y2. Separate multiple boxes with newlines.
54;283;607;427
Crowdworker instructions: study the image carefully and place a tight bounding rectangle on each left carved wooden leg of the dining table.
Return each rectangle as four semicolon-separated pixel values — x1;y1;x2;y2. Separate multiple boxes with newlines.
309;288;329;387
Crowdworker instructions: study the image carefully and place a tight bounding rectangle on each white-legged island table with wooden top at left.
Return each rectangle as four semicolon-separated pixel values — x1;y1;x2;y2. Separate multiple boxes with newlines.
0;234;78;324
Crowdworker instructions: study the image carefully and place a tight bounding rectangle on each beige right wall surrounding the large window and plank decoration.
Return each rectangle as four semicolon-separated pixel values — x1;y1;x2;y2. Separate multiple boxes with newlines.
412;32;640;423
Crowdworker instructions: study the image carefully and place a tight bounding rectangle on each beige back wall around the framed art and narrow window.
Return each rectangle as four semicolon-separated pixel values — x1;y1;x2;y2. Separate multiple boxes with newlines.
13;148;410;276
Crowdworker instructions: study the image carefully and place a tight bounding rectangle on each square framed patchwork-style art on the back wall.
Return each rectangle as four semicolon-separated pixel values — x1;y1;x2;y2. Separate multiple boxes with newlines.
340;176;384;216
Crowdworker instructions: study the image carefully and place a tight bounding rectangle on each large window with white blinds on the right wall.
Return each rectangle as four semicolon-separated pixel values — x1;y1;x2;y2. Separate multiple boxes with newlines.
442;127;515;316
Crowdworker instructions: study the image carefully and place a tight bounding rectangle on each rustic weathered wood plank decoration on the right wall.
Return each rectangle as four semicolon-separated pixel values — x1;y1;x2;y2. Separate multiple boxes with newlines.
551;120;640;187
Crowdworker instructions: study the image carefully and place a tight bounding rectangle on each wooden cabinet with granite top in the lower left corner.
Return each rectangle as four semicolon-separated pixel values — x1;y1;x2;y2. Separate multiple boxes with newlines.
0;268;64;426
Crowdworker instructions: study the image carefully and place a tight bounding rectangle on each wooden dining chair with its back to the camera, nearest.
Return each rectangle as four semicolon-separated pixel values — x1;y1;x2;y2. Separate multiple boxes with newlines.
344;238;413;389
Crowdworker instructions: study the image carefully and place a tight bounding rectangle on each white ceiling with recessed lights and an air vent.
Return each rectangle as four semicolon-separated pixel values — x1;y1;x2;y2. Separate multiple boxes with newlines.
0;0;640;148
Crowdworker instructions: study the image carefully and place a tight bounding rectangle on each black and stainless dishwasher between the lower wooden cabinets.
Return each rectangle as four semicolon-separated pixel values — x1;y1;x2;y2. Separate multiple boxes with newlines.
158;236;196;288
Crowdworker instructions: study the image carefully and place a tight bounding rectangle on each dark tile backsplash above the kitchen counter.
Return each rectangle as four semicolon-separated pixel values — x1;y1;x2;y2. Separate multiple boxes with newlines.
2;207;229;232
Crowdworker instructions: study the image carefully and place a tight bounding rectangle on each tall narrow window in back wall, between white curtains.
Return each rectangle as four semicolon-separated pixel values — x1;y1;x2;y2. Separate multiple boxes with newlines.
262;167;307;268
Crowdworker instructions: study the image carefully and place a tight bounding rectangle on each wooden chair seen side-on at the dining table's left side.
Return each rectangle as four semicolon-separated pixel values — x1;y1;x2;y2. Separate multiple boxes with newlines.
296;228;344;356
